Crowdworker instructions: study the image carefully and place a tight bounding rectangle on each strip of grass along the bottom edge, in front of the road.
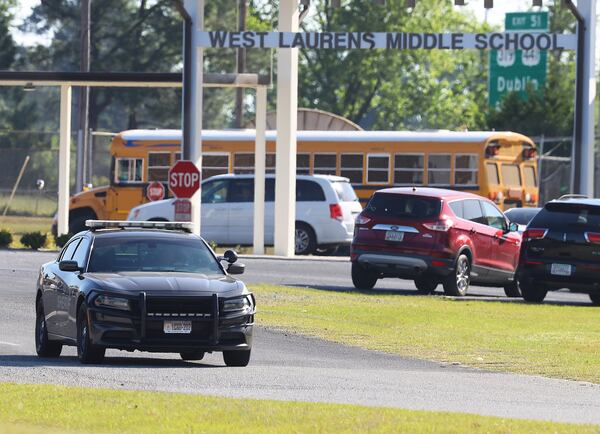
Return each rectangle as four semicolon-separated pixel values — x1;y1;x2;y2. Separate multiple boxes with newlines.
0;383;598;433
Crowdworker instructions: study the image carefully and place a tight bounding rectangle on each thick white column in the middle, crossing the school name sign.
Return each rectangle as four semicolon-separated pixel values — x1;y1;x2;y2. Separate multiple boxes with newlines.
275;0;299;256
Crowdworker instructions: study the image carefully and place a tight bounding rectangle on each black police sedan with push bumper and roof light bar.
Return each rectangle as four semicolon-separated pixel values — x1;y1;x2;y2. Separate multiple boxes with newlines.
35;220;255;366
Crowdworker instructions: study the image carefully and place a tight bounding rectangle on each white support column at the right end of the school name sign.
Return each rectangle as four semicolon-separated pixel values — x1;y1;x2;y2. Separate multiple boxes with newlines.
577;0;596;197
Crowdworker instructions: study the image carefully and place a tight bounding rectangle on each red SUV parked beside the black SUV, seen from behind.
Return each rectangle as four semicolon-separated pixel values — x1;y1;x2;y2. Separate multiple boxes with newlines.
351;187;521;297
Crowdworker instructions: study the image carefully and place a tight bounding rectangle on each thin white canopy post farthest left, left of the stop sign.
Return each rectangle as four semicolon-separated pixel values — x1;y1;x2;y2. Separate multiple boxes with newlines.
57;84;71;235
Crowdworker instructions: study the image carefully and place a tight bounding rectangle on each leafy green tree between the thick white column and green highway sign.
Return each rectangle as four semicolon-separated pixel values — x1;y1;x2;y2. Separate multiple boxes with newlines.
299;0;487;130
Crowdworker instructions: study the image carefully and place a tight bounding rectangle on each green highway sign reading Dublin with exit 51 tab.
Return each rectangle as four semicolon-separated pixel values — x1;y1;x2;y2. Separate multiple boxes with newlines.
488;12;549;107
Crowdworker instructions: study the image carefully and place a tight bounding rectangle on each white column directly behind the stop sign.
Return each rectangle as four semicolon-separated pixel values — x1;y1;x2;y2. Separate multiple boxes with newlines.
185;0;204;234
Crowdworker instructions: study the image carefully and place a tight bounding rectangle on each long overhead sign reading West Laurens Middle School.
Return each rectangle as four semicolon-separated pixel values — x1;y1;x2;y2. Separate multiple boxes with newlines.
198;31;577;51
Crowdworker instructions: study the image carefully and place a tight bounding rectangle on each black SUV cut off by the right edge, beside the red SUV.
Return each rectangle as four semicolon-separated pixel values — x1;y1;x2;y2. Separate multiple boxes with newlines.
519;198;600;305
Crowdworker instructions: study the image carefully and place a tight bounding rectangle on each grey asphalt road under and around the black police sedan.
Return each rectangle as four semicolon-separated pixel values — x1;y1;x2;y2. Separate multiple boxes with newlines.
0;251;600;424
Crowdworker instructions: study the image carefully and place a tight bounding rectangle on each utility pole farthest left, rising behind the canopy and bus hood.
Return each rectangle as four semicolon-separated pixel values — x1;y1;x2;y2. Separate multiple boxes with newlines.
76;0;91;192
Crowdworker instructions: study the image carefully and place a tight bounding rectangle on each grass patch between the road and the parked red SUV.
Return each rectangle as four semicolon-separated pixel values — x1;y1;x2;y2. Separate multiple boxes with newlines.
251;285;600;383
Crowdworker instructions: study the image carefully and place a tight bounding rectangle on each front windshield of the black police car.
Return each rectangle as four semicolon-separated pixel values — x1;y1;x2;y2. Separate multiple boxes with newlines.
88;235;224;274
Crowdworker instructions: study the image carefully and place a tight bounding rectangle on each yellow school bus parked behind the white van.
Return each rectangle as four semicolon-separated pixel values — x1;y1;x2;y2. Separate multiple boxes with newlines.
64;130;538;232
